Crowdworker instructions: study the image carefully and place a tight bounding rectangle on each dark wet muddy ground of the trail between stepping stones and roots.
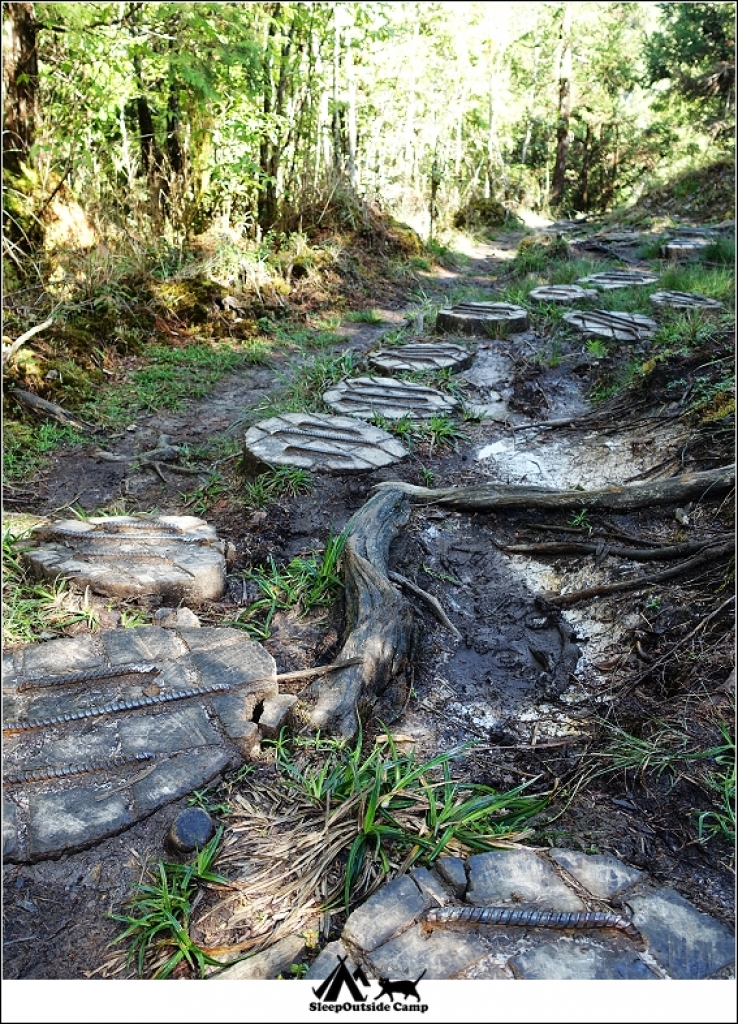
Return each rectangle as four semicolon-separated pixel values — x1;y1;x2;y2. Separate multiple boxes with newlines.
3;226;734;979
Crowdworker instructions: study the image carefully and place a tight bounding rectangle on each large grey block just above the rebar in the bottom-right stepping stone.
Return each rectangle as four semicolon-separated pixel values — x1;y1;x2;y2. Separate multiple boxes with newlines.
467;849;585;910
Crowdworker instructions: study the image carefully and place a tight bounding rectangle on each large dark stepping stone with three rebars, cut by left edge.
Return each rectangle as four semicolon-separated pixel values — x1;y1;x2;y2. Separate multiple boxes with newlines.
3;626;277;862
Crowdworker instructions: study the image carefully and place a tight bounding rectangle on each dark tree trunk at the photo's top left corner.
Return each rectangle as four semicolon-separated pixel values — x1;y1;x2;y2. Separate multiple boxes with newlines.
2;3;38;175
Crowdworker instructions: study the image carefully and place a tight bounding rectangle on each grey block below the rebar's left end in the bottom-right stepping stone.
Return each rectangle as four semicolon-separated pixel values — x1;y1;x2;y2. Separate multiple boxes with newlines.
367;925;488;981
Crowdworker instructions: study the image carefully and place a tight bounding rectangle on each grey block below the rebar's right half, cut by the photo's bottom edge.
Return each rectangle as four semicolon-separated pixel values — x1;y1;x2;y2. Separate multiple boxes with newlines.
510;938;656;981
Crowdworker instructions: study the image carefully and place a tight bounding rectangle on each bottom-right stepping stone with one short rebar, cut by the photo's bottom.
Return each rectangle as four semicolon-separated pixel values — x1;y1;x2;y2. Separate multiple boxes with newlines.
307;848;735;981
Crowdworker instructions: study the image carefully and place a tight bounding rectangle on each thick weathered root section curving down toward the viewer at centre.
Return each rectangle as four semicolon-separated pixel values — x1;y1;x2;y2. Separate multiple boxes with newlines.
310;488;413;738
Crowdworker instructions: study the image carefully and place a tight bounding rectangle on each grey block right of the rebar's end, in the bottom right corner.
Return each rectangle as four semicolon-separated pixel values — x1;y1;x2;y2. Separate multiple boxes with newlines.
627;889;735;981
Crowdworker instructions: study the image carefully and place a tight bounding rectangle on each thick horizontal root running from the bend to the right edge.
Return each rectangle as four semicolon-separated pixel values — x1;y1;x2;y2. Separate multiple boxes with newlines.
375;466;735;512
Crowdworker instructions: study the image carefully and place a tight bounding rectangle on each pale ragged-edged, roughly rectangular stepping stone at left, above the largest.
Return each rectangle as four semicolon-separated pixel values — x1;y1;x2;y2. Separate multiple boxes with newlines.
25;515;226;603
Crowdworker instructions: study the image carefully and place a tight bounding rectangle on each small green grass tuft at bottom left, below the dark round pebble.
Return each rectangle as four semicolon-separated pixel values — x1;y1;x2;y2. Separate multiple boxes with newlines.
111;825;229;978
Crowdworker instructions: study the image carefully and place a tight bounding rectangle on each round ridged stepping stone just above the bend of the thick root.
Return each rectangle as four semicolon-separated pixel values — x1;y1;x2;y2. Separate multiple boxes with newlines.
245;409;407;473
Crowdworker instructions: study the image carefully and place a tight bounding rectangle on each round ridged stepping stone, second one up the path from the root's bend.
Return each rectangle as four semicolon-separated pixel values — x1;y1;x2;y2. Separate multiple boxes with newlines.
322;377;458;420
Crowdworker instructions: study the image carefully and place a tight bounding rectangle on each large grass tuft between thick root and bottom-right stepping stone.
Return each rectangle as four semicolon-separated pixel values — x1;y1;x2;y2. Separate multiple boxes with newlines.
268;730;547;910
